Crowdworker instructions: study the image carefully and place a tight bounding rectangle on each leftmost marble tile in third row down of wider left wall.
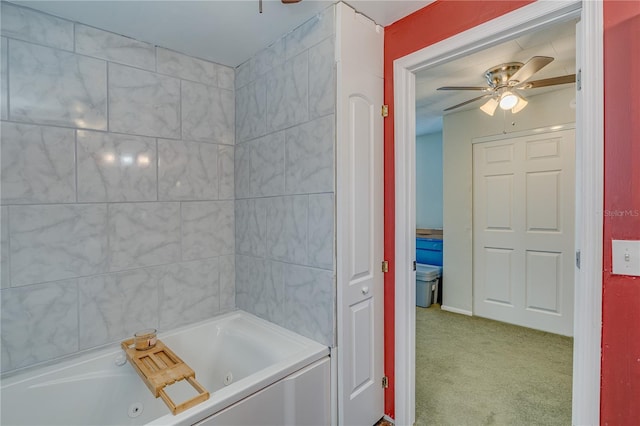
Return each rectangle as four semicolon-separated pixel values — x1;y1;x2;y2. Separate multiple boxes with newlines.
1;122;76;204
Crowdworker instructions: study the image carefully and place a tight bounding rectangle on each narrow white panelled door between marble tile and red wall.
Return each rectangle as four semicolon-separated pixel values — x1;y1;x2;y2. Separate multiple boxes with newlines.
336;3;384;426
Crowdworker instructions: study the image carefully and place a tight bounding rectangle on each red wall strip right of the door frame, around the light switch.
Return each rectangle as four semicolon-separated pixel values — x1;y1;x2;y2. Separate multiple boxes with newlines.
600;1;640;425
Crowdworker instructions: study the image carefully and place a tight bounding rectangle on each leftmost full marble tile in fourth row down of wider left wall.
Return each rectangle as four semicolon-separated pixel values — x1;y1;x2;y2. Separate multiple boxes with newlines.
9;204;107;286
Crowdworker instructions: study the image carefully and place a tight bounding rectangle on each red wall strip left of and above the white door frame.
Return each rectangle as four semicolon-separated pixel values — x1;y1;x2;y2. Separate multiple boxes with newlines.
384;0;531;417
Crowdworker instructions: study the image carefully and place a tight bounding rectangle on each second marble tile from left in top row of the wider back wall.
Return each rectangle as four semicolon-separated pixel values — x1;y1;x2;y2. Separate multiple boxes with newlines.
76;24;156;71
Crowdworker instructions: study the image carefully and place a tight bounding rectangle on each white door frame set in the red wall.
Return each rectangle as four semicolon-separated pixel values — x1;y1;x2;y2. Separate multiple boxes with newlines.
393;0;604;425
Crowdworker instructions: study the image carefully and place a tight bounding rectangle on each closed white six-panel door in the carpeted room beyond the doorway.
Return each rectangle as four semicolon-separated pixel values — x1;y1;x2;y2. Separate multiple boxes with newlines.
473;129;575;336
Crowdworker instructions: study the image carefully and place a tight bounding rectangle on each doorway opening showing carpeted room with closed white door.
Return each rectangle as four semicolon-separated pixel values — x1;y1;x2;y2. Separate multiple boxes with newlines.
415;15;576;424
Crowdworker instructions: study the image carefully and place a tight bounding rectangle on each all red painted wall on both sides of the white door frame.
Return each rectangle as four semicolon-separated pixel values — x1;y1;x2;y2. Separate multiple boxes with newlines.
384;0;640;425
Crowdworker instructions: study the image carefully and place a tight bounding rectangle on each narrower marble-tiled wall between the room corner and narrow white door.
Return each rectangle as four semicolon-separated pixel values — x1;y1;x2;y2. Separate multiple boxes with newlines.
235;7;336;346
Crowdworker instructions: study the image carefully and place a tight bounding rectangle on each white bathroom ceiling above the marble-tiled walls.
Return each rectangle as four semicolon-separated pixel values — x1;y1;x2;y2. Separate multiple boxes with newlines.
13;0;433;67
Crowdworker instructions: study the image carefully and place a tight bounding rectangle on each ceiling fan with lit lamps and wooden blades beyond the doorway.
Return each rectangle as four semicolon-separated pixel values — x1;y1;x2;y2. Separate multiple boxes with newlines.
438;56;576;115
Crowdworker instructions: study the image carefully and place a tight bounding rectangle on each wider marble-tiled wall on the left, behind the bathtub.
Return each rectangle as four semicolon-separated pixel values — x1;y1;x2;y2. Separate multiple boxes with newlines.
0;2;235;372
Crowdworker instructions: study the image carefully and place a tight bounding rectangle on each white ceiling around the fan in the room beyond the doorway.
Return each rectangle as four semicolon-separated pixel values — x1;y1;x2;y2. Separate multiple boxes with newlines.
416;17;576;135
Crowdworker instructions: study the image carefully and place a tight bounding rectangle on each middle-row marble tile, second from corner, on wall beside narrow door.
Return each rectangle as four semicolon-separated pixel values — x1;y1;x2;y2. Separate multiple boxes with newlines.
248;131;284;196
